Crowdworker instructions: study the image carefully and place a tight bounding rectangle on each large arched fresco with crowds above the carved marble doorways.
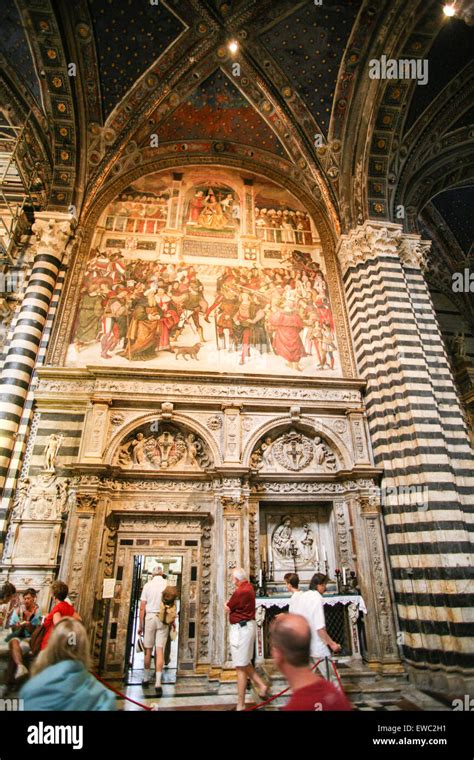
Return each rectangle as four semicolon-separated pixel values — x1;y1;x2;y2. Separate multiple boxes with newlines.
67;172;341;377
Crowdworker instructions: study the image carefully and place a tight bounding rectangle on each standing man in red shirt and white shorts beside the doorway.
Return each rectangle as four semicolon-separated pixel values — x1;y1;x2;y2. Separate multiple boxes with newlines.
224;567;269;710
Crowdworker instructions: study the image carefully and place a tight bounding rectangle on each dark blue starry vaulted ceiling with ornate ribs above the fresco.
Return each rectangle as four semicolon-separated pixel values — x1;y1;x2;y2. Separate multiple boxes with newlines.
3;0;474;246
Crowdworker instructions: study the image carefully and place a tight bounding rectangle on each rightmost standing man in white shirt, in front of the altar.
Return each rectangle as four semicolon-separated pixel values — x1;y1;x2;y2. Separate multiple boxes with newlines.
296;573;341;680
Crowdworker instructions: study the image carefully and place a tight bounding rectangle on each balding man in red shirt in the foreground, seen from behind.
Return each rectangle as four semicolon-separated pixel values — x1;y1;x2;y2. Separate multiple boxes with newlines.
271;615;352;711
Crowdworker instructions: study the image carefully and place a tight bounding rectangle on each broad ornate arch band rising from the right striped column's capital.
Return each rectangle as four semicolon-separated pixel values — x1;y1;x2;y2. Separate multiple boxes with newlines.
329;0;439;230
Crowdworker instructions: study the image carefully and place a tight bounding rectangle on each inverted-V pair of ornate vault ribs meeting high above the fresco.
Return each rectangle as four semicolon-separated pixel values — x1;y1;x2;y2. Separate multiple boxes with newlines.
78;0;340;232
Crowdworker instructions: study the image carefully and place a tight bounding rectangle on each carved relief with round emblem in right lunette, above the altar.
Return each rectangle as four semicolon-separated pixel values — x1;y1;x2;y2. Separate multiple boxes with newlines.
250;429;337;472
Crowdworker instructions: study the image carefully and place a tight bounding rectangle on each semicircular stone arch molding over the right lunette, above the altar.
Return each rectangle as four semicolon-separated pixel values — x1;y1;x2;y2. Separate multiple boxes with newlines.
242;415;352;472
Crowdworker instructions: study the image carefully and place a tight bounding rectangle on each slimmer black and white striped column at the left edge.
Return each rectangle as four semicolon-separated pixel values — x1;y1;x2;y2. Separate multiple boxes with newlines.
0;212;73;510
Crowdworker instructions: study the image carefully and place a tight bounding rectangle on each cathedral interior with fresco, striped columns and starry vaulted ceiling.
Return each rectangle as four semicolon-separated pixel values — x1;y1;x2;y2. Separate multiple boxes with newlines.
0;0;474;710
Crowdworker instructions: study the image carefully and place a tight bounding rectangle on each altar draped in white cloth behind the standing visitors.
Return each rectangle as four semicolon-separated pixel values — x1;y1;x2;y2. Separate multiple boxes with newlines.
255;594;367;662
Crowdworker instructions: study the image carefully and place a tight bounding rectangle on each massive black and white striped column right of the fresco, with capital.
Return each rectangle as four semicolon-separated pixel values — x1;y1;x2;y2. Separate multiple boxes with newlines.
339;222;474;692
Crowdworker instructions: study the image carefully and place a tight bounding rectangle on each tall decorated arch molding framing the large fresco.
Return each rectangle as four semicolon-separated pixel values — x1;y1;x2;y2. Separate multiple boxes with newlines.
48;148;357;377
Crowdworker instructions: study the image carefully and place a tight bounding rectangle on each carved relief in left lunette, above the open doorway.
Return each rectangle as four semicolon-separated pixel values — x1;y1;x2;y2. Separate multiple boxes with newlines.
115;422;212;471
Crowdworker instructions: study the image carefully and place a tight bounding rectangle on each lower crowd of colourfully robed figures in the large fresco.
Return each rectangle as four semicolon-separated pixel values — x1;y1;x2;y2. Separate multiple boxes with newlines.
73;250;336;370
